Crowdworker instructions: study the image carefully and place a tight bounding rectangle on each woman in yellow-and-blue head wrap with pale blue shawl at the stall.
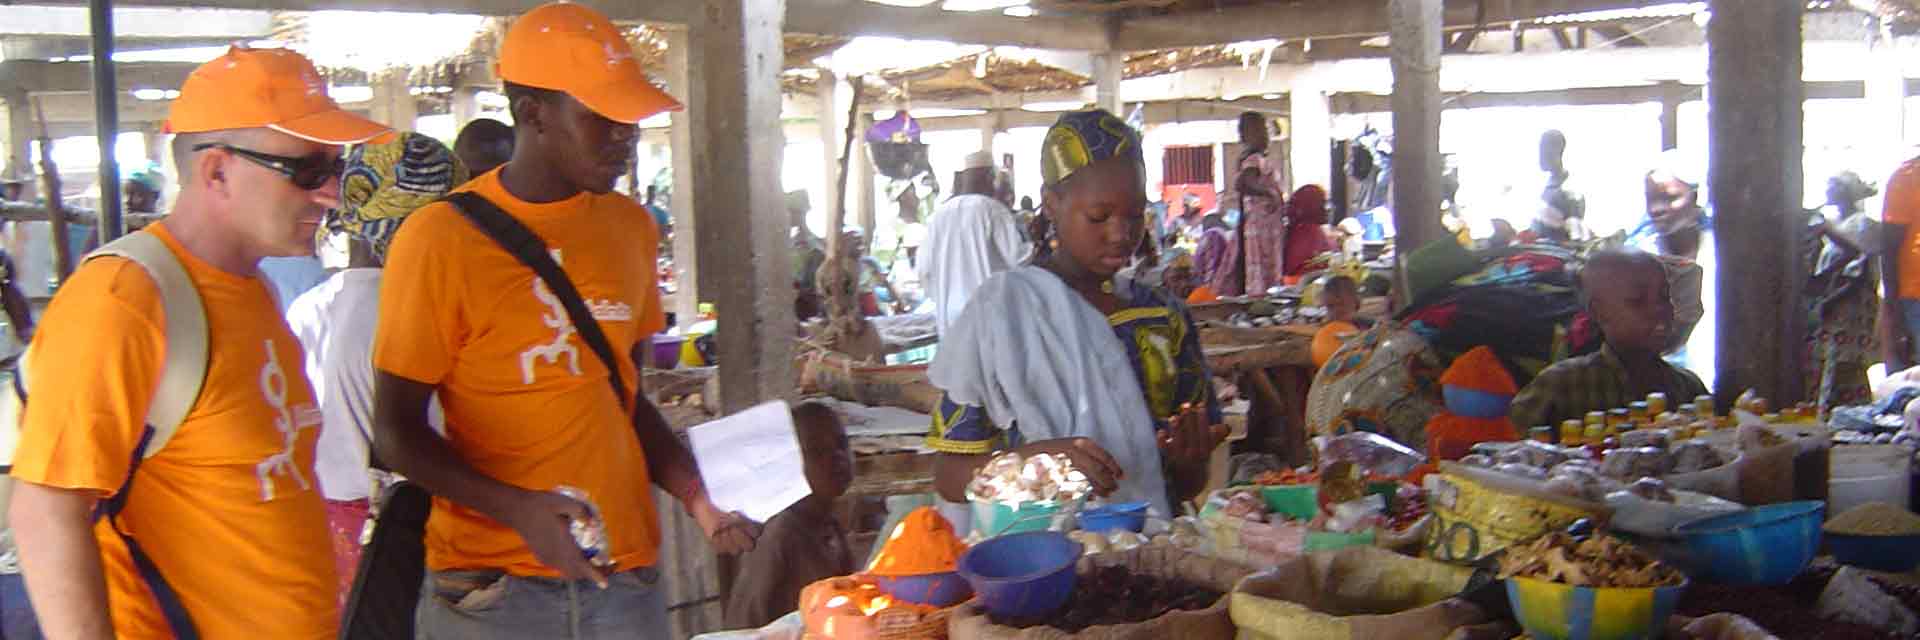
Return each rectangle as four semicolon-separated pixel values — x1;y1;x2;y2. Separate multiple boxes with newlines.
927;111;1221;527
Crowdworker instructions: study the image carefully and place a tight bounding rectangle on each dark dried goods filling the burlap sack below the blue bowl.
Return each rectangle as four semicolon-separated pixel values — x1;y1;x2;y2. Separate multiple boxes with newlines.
993;565;1223;632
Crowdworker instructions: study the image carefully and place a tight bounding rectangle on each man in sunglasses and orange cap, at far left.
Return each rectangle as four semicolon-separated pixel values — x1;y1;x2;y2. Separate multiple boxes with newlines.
12;46;388;640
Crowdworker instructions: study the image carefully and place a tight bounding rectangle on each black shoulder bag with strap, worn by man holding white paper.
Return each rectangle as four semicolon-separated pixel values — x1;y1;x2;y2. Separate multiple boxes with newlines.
340;192;636;640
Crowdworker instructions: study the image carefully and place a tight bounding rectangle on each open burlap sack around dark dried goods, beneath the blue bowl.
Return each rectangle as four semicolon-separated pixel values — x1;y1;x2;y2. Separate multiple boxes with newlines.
947;544;1254;640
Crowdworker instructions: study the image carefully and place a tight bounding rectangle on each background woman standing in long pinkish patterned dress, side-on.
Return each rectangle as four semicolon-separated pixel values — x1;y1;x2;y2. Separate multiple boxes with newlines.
1212;111;1286;296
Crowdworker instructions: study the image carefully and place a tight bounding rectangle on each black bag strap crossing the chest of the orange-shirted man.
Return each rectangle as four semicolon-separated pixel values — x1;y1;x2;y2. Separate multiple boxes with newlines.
447;192;634;407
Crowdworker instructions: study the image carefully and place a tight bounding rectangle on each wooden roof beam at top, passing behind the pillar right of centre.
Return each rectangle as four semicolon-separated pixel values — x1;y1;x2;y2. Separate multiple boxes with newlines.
1114;0;1659;52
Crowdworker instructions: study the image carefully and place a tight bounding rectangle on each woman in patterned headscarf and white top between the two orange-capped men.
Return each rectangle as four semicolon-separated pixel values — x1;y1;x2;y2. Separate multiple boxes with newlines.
286;133;467;603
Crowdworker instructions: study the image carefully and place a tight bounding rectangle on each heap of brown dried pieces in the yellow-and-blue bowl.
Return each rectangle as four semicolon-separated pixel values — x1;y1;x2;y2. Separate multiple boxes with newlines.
1500;532;1686;588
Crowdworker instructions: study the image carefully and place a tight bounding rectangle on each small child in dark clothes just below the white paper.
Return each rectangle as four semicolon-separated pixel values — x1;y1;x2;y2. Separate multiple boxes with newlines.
724;402;854;628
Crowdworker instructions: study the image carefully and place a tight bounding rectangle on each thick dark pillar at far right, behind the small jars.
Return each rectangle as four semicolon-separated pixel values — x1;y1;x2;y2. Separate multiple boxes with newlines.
1704;0;1807;406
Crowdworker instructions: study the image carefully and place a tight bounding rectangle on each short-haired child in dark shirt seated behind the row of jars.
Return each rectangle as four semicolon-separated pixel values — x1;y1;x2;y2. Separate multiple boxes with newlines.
1509;250;1707;431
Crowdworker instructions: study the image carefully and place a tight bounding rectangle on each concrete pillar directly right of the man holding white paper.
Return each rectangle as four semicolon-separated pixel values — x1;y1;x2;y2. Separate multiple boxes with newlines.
689;0;795;413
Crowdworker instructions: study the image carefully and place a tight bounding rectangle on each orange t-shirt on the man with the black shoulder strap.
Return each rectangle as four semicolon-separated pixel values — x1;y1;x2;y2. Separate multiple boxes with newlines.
372;171;666;577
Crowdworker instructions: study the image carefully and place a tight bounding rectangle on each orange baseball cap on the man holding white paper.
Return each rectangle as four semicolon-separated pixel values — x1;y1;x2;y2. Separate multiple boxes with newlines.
495;2;682;123
